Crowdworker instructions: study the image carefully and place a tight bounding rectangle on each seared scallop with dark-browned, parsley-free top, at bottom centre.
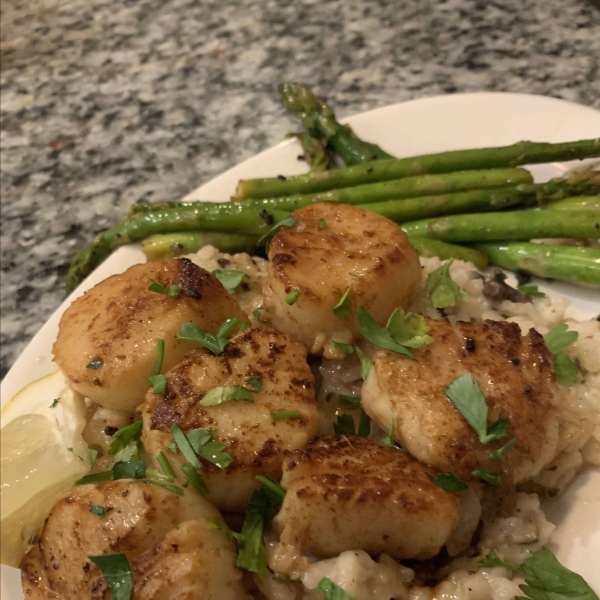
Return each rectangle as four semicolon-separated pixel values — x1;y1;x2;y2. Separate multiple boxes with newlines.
271;436;460;572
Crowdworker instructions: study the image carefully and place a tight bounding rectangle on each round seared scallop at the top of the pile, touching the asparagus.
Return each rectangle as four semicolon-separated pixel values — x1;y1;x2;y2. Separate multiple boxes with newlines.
263;204;421;358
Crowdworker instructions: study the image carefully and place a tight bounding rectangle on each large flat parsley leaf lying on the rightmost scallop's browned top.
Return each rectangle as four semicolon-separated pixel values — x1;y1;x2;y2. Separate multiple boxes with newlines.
446;373;508;444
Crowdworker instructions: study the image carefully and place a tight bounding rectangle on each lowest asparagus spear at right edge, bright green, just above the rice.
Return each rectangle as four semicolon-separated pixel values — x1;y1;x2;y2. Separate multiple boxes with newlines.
476;242;600;286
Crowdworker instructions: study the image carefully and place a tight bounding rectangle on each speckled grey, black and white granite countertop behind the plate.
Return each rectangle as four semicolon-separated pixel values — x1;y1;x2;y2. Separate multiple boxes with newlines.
1;0;600;376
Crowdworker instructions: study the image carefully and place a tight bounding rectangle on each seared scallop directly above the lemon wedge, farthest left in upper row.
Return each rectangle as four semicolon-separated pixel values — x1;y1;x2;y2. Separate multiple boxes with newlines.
53;258;247;413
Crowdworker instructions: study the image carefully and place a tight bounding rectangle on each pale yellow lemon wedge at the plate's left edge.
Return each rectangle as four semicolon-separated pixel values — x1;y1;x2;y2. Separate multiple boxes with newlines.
0;371;90;567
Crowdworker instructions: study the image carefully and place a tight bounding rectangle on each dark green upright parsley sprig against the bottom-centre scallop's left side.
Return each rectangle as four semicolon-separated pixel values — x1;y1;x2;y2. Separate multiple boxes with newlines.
236;474;283;575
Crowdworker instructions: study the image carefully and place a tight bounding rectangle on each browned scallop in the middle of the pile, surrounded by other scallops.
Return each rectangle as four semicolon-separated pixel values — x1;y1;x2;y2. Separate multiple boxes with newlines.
142;329;319;512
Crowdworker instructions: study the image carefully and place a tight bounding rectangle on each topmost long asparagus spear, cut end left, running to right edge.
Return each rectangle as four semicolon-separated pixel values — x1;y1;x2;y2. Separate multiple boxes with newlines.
233;138;600;200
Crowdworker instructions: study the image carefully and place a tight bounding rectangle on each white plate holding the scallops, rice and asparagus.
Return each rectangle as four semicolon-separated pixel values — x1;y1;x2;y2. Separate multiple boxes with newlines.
0;93;600;600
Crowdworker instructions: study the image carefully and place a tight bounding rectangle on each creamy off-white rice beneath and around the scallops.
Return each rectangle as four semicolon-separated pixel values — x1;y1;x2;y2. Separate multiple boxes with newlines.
189;246;600;600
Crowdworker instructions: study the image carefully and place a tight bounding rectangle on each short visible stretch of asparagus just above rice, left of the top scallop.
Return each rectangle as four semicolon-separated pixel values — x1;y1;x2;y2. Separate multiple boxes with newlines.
142;231;258;260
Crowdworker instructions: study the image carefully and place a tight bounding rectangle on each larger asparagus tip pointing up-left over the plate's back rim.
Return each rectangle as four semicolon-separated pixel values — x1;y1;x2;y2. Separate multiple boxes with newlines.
277;83;394;165
